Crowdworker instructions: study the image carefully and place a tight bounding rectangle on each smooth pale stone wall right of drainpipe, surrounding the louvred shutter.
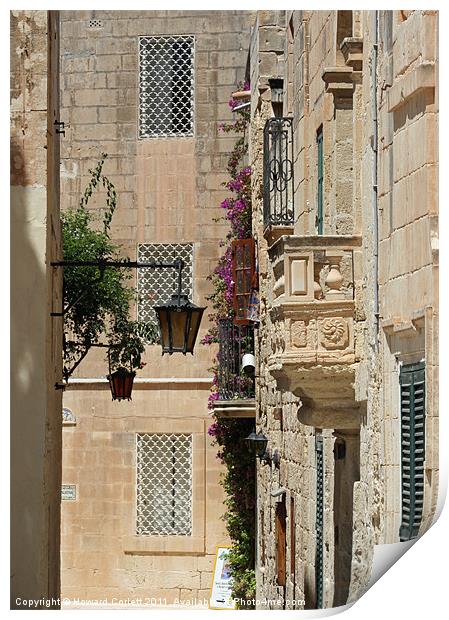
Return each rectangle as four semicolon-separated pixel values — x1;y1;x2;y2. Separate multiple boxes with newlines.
379;11;439;542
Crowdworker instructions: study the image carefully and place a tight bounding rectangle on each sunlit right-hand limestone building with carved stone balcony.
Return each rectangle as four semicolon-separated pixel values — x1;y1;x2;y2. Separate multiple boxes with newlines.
247;11;438;609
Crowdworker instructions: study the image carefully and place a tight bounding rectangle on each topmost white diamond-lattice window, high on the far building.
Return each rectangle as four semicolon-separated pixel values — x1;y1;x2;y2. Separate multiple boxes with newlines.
139;36;195;138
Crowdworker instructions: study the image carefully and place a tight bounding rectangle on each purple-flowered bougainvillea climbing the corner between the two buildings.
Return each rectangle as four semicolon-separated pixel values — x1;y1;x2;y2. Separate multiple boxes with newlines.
202;83;256;609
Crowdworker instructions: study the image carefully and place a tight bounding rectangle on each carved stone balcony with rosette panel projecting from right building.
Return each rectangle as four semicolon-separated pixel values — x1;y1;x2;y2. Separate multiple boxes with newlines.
267;236;363;428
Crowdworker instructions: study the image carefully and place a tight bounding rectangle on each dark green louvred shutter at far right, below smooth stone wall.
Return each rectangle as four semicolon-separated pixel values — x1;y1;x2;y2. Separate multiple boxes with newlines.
399;362;426;541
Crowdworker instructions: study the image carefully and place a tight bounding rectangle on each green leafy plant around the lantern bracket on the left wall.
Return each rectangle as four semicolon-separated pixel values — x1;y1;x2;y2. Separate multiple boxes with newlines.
61;153;158;379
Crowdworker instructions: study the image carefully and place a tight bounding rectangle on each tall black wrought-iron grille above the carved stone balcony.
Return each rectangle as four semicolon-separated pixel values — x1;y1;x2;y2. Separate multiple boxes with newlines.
263;117;295;227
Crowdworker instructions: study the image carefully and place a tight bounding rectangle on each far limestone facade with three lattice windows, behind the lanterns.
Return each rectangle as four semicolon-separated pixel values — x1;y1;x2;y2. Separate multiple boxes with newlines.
57;11;252;605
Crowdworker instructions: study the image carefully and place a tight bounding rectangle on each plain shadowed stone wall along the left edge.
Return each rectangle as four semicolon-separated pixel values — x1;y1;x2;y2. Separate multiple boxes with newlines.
11;11;62;609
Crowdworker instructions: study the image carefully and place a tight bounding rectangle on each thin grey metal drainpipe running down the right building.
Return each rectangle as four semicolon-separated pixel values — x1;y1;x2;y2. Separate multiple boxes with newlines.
371;11;379;350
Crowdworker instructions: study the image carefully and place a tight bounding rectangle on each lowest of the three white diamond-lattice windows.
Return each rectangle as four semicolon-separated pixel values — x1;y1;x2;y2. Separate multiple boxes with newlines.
136;433;192;536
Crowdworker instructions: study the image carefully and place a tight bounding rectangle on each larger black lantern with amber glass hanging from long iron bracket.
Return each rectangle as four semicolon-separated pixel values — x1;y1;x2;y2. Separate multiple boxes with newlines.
154;294;206;355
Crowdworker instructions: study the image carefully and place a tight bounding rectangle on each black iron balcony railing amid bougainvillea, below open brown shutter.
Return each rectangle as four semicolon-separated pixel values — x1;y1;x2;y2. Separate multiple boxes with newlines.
218;319;254;400
